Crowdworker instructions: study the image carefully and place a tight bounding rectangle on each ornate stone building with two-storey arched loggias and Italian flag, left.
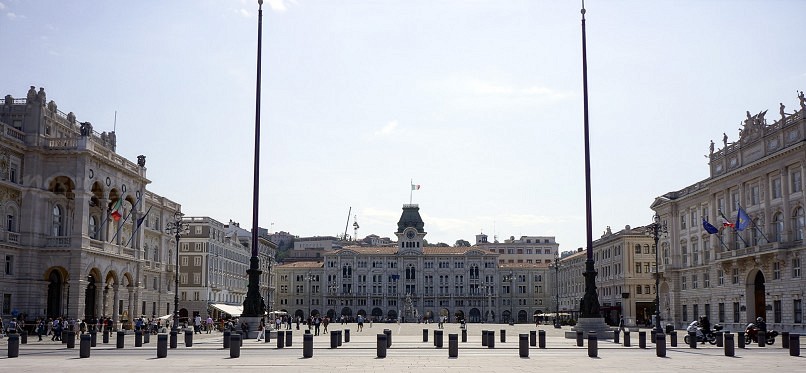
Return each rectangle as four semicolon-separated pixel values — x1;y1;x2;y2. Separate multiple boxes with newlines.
0;87;181;322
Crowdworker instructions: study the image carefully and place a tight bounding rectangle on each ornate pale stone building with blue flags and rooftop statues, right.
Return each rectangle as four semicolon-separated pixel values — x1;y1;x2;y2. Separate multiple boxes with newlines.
651;92;806;331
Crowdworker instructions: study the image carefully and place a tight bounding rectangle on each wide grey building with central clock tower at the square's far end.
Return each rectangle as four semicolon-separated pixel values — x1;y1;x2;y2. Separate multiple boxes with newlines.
276;205;551;322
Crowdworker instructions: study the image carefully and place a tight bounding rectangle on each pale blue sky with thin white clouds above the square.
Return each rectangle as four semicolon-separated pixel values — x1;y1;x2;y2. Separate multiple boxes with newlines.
0;0;806;250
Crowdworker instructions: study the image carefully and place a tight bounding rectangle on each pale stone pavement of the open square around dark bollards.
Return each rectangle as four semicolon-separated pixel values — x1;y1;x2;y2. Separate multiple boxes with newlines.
0;323;806;373
